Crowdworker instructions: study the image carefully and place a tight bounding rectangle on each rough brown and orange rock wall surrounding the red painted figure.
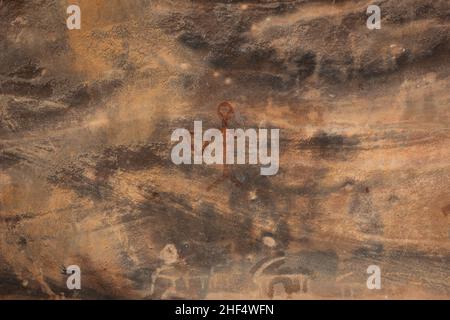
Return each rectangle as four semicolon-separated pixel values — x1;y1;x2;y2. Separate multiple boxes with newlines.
0;0;450;299
